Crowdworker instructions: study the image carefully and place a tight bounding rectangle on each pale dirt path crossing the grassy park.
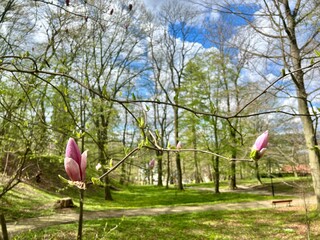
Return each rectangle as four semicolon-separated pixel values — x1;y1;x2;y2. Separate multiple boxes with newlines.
7;197;316;236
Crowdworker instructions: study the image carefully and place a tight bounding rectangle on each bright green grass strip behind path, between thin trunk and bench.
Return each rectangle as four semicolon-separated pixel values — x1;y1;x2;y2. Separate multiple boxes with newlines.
75;183;281;211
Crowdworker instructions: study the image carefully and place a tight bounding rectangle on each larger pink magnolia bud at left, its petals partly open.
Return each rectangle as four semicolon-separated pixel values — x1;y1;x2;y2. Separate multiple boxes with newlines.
64;138;87;182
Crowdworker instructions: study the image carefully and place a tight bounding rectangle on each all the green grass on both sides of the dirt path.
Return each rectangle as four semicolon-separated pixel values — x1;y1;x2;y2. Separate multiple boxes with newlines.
0;175;320;239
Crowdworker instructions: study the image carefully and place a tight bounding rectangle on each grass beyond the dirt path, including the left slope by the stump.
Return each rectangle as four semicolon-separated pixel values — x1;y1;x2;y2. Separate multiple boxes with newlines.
0;176;312;221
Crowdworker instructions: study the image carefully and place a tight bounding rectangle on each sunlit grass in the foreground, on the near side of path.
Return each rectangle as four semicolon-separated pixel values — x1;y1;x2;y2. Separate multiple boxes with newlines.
14;207;320;240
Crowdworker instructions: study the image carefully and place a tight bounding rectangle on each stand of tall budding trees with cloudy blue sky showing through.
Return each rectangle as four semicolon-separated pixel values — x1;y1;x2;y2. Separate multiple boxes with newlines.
0;0;320;206
